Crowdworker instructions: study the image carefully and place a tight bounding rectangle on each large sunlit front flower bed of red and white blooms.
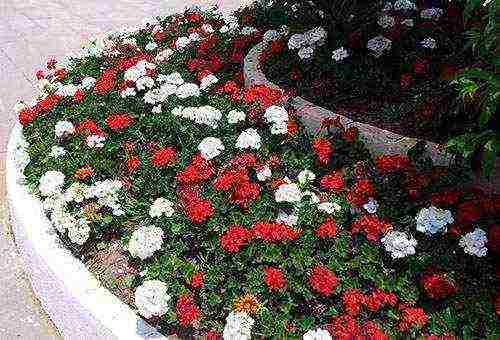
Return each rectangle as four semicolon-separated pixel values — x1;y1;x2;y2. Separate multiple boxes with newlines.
10;3;500;339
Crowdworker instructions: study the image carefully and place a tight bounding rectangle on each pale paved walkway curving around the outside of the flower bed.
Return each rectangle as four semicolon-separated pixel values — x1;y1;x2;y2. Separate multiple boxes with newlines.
0;0;249;340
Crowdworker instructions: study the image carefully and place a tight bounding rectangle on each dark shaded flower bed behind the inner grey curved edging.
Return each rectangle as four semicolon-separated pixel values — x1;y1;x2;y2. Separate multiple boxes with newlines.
240;0;496;142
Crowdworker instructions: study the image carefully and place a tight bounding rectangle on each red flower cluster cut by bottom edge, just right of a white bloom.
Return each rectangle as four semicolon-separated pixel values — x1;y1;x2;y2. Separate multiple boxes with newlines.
327;315;389;340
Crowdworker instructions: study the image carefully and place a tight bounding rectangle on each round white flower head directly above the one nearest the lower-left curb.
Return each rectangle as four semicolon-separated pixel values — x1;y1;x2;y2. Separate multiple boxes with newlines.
128;226;163;260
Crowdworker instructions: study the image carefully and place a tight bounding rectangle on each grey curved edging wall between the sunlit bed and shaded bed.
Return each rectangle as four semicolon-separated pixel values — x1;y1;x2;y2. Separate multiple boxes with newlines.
244;41;451;165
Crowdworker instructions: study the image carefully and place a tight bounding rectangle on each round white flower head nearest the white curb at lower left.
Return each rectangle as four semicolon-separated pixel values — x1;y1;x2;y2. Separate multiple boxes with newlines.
134;280;171;319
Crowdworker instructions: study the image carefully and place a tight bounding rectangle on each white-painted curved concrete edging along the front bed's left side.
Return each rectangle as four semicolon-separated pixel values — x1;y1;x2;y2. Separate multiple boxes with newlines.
6;124;167;340
